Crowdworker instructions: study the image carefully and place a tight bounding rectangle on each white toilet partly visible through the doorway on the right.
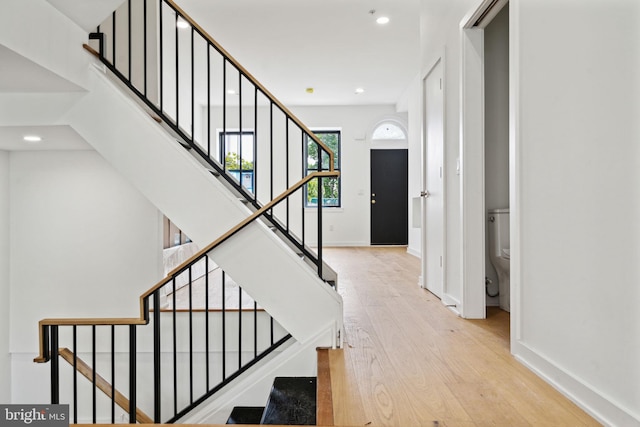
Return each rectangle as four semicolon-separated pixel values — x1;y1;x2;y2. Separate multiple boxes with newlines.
488;209;511;311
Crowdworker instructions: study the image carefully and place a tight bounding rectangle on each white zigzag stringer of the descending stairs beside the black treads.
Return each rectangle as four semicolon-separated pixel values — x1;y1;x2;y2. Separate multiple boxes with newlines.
178;325;333;425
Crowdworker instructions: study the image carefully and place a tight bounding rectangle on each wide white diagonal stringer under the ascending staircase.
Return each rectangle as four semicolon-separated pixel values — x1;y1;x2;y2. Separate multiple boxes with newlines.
60;65;342;346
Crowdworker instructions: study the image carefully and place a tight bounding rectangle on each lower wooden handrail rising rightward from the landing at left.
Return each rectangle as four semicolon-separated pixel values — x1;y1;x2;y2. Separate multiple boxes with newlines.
33;171;340;363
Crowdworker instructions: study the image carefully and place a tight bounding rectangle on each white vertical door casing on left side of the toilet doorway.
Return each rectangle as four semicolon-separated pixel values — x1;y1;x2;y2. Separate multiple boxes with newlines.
460;21;486;319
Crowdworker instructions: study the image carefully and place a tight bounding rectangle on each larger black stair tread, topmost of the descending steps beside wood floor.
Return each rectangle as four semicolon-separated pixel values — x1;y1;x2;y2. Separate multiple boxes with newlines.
260;377;317;425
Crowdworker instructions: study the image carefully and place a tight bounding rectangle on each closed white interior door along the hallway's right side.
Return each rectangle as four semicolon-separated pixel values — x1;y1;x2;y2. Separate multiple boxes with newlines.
422;60;444;298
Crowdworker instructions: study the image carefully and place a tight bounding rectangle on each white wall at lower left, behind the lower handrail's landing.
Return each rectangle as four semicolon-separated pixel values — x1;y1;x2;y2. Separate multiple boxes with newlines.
10;151;162;357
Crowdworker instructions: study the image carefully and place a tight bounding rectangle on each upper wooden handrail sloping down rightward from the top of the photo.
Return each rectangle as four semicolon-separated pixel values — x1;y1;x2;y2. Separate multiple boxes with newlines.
164;0;335;172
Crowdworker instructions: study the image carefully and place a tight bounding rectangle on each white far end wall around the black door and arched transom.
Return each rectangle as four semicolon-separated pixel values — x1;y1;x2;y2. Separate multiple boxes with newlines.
292;105;407;246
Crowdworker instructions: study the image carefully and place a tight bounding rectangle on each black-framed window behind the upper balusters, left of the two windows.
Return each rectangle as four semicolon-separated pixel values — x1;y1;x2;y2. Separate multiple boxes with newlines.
220;131;255;193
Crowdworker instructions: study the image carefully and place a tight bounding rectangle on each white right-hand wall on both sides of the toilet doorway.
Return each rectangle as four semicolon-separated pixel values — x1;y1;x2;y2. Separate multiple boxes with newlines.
421;0;640;426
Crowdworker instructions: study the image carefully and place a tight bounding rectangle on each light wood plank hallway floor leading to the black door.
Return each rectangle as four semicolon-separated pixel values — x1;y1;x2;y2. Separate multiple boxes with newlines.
324;247;599;427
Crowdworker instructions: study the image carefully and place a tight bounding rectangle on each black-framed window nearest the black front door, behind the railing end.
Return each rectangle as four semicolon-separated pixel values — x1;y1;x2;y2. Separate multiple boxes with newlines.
305;130;341;208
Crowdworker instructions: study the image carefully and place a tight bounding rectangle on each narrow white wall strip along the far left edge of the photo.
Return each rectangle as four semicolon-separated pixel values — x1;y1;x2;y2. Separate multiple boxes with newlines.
0;151;11;403
